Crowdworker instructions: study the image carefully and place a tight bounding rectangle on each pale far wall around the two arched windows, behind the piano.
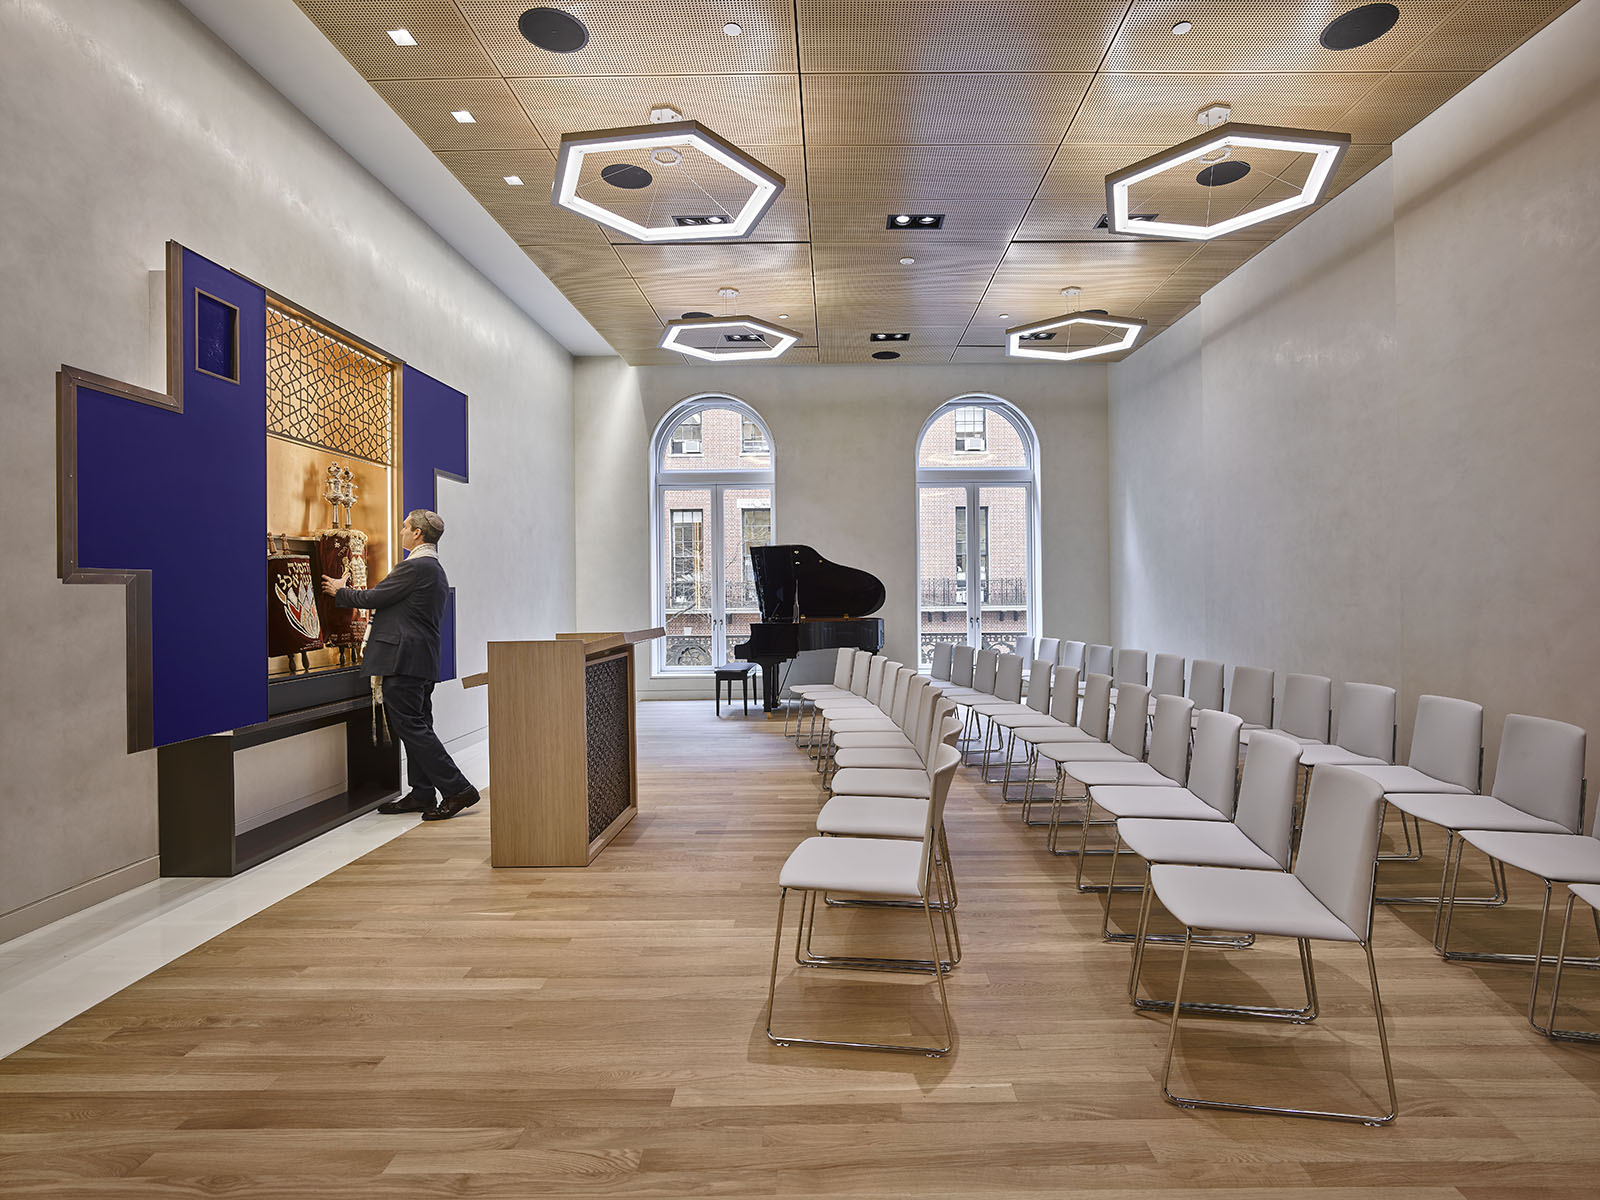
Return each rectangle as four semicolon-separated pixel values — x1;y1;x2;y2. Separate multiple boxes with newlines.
574;358;1110;696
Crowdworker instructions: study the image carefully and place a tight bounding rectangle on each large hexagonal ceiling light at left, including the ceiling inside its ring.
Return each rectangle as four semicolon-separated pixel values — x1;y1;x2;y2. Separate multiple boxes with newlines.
550;118;784;242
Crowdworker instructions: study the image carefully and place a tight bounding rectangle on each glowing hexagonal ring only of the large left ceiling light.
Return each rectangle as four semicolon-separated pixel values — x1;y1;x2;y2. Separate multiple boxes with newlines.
550;120;784;242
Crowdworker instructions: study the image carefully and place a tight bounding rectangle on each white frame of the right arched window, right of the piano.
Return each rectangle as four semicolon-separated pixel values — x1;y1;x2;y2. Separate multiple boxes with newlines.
912;400;1042;662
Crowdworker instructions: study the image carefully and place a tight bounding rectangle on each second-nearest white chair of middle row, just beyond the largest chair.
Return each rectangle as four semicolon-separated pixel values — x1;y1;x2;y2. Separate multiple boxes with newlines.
1101;732;1299;947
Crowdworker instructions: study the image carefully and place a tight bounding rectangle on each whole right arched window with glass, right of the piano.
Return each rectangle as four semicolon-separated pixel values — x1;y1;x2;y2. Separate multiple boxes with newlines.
917;395;1038;666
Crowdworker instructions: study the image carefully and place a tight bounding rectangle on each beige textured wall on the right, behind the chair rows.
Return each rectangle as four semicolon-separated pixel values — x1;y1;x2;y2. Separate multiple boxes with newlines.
1110;0;1600;812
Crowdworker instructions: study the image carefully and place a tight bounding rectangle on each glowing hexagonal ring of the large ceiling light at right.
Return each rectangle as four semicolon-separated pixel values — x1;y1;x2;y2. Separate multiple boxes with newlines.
1106;122;1350;242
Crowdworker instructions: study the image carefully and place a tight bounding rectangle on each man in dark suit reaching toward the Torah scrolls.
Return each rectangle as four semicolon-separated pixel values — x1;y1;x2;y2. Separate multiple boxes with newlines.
322;509;478;821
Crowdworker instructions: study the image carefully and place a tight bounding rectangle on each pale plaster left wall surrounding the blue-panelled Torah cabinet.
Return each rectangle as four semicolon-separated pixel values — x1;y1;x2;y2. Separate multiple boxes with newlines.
0;0;573;931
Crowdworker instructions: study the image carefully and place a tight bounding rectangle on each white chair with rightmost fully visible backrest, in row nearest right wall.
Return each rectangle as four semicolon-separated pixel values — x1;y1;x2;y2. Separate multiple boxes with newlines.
1378;712;1589;921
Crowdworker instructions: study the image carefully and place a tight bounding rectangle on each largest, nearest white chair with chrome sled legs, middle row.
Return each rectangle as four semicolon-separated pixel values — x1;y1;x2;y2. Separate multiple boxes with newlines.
1136;766;1395;1125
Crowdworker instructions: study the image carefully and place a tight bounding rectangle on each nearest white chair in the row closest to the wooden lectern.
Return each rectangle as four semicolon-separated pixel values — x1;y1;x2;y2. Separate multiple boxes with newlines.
766;747;960;1058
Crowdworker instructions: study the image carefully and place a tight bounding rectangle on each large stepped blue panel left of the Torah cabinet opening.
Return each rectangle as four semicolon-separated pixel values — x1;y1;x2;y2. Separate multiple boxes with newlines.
77;251;267;746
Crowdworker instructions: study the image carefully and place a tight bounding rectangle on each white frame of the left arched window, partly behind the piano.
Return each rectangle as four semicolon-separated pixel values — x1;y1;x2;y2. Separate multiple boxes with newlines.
650;392;778;678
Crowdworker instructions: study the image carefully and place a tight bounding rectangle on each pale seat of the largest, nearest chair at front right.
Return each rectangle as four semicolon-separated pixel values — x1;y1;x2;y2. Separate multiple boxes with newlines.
1152;870;1360;942
